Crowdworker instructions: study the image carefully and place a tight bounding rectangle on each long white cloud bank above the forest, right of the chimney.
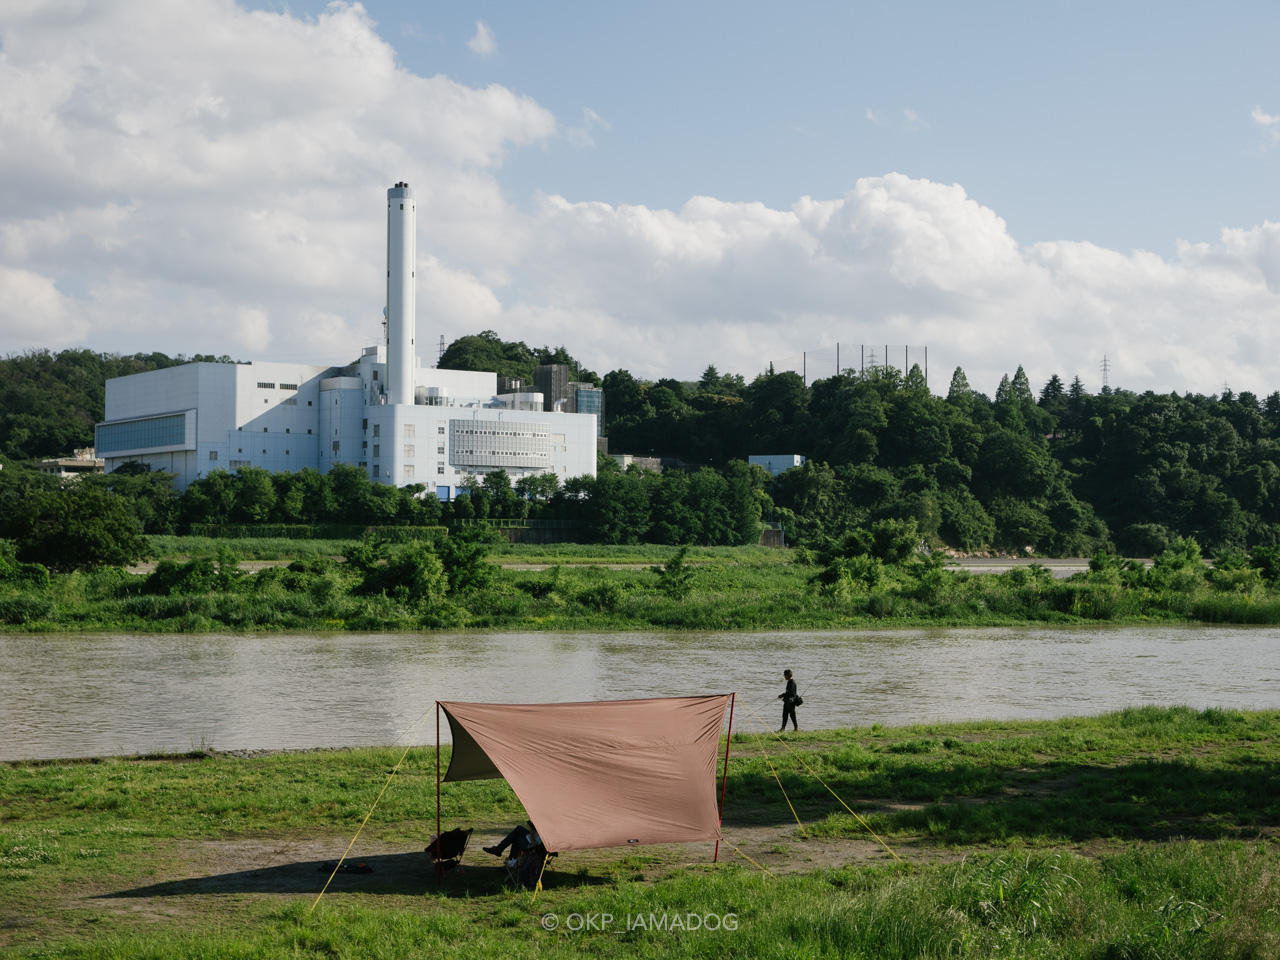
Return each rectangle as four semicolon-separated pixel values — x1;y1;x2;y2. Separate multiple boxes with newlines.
508;180;1280;392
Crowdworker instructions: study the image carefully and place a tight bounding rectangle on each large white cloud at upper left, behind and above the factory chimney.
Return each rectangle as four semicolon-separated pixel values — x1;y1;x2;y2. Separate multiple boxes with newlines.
0;0;556;362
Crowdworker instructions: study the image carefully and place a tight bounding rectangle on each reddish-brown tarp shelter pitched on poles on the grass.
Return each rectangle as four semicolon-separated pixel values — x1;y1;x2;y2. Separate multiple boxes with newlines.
436;694;733;852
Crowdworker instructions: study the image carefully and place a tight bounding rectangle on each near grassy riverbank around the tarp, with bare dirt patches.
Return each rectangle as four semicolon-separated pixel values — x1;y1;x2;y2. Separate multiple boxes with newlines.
0;708;1280;957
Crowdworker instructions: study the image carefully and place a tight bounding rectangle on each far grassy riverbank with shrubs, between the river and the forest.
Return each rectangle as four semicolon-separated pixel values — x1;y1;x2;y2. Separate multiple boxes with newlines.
0;538;1280;632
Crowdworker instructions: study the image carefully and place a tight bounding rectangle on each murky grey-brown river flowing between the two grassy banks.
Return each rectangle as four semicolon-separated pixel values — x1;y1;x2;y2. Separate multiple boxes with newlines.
0;626;1280;760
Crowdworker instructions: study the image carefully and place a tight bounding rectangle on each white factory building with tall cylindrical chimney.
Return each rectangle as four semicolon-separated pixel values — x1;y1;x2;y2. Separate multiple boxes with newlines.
96;183;598;499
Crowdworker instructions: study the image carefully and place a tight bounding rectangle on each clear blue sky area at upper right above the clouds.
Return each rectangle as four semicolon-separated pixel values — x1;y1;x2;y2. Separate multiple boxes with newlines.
252;0;1280;255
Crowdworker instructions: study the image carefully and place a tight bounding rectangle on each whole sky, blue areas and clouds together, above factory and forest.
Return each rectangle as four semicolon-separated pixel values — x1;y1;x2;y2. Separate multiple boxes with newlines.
0;0;1280;394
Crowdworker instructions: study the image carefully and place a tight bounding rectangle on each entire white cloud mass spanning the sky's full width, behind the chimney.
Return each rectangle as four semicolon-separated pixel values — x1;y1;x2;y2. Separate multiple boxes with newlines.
0;0;1280;392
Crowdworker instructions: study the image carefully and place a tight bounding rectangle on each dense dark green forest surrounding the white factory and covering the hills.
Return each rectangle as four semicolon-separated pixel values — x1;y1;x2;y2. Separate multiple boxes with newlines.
0;343;1280;556
